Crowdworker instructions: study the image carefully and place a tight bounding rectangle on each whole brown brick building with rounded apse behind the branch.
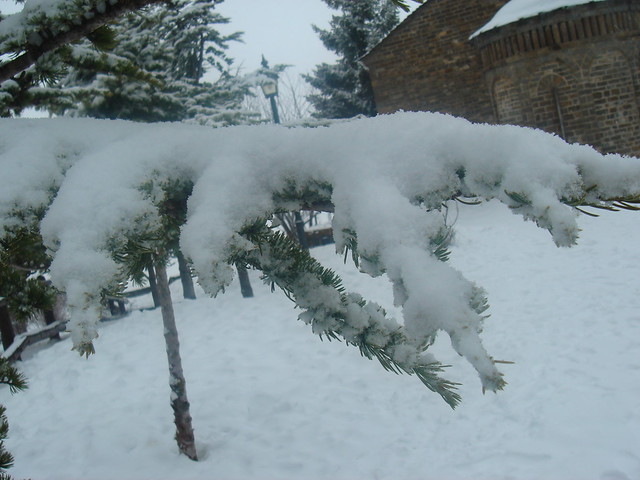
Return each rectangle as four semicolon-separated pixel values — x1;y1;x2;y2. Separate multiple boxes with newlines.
363;0;640;156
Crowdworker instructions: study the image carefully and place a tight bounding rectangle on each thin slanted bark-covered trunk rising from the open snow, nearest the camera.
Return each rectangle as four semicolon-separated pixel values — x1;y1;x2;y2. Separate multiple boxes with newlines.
155;262;198;460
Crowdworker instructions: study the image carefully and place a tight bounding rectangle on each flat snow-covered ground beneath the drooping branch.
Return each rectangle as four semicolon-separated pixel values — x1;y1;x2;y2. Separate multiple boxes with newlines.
0;203;640;480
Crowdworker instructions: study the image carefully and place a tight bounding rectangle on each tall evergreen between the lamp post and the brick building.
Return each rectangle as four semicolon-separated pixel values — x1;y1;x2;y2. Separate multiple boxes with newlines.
304;0;399;118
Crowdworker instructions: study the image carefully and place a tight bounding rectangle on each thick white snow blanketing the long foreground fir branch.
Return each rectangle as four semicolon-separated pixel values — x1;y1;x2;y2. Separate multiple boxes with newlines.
0;113;640;403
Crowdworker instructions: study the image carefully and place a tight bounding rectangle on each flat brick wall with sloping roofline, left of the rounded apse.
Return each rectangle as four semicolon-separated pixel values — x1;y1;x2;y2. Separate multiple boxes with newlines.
363;0;507;122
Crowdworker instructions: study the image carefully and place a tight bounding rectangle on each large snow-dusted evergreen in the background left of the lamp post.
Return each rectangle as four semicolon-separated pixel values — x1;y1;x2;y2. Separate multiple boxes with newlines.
48;0;248;126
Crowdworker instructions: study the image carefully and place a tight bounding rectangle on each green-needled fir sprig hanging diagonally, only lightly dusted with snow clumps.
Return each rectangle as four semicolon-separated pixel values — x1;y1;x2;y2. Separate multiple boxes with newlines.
229;220;460;407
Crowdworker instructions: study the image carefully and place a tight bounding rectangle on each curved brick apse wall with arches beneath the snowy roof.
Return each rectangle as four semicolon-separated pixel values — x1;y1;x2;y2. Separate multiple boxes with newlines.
474;0;640;156
